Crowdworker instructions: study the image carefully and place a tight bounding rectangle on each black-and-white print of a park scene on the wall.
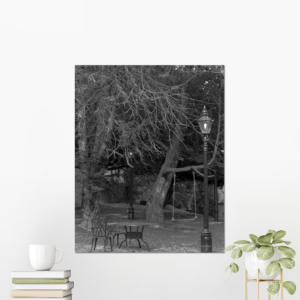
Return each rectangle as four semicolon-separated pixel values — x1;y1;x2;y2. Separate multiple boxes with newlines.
75;65;225;253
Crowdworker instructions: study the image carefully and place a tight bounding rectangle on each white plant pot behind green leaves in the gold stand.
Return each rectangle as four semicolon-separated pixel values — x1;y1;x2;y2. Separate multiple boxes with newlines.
244;249;284;280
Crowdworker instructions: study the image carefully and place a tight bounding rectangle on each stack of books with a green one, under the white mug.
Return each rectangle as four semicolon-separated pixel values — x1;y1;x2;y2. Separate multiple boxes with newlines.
11;271;74;300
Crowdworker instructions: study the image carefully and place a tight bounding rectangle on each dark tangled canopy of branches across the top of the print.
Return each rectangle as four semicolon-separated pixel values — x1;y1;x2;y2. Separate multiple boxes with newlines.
75;66;224;226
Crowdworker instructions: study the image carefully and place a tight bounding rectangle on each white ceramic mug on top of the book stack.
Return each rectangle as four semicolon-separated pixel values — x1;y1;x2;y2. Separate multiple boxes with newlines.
29;245;63;271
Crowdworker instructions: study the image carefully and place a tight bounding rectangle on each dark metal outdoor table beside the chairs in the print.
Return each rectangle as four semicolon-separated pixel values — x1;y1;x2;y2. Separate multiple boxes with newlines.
118;222;150;251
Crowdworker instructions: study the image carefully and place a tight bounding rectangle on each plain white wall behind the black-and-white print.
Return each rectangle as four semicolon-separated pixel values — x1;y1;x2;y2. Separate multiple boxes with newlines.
0;1;300;300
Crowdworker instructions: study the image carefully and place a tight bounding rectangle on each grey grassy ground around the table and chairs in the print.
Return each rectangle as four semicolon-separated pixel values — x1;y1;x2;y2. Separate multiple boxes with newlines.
75;203;224;253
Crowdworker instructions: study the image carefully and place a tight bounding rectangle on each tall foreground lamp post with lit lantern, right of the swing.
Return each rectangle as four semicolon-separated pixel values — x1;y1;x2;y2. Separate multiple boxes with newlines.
198;105;213;253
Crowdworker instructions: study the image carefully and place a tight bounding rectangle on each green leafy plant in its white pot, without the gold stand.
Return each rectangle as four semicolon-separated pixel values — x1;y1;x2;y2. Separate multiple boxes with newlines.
224;230;296;295
